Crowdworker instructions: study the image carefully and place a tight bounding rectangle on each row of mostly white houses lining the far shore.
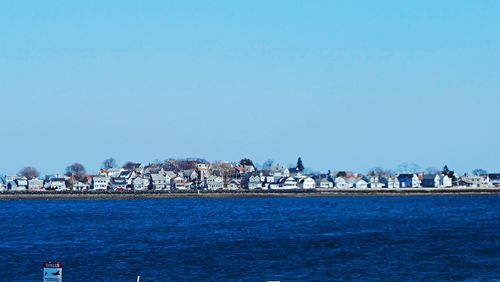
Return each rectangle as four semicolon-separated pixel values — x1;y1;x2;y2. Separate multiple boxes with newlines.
0;164;500;191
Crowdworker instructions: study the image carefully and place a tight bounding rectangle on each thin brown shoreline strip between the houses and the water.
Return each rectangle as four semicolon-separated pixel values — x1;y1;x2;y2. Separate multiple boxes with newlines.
0;188;500;201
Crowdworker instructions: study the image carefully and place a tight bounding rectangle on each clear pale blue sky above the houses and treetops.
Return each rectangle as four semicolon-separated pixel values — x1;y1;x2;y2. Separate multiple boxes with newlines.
0;0;500;176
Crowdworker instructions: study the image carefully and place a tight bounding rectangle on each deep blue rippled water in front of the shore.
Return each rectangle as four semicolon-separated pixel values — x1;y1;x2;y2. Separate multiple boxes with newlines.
0;196;500;282
